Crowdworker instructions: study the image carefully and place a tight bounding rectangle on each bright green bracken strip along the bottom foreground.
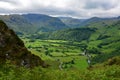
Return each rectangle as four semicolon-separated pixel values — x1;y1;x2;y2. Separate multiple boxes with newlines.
0;63;120;80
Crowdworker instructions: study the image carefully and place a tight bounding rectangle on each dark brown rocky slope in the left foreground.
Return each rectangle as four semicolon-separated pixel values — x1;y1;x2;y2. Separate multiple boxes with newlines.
0;21;46;67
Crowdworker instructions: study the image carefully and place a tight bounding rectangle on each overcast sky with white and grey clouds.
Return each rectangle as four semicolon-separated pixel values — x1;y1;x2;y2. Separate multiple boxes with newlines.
0;0;120;18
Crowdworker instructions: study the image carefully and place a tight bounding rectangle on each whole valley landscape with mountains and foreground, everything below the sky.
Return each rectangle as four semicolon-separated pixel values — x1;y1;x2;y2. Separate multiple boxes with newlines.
0;14;120;80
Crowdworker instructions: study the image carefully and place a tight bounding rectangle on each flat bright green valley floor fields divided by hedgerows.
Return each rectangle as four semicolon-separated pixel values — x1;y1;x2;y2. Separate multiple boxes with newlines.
22;38;88;70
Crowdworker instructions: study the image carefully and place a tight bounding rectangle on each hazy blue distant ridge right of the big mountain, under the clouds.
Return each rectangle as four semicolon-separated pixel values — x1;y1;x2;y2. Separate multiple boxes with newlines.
58;17;120;28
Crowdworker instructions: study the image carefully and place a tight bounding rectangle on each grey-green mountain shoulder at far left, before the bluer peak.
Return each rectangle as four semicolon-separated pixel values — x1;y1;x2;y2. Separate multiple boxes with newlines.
0;14;35;34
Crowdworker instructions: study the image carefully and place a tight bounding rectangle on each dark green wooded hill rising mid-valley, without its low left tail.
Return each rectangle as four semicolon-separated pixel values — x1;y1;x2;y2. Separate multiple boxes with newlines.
49;28;94;41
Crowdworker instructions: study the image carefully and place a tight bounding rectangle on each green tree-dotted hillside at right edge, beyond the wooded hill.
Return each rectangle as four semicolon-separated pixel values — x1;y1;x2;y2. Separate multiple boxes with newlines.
88;21;120;63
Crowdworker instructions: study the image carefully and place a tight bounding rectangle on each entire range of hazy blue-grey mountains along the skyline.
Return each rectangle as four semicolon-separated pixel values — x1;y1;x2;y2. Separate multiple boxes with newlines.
0;14;120;34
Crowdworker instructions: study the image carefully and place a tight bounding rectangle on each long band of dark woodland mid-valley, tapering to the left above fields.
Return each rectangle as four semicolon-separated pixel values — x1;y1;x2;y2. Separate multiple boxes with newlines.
30;28;95;41
